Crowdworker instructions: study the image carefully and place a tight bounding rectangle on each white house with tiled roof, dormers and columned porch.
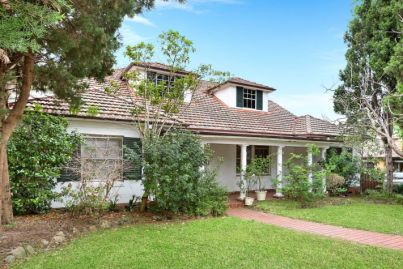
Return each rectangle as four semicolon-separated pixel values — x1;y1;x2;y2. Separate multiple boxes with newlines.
29;63;340;203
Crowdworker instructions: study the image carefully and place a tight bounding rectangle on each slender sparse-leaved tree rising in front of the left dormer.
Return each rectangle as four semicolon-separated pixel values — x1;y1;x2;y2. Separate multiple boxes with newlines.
125;30;229;211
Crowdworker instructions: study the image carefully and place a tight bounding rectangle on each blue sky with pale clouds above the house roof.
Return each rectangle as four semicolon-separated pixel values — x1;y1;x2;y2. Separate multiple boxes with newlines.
116;0;353;120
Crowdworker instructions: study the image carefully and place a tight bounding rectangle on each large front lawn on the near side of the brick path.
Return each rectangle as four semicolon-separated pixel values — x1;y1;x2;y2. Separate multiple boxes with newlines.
13;217;403;269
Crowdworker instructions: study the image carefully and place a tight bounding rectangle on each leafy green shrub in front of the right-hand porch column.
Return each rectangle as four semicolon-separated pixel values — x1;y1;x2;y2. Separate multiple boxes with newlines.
283;146;324;207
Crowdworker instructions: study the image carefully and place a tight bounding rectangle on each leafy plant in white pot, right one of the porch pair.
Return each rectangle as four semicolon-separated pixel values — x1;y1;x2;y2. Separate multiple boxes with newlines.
249;157;271;201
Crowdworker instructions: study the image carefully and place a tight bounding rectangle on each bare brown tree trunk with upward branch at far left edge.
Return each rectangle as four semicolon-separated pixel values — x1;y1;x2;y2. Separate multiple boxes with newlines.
0;53;34;224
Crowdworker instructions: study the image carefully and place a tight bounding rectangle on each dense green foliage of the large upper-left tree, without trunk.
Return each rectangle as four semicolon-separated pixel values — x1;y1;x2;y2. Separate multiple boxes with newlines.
0;0;166;105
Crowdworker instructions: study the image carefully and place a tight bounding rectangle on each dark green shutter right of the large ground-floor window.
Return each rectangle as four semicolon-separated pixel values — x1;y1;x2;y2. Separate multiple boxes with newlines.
123;137;142;180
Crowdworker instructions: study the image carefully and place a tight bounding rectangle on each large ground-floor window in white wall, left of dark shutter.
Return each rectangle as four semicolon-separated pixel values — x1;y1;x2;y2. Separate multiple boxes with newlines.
81;136;123;181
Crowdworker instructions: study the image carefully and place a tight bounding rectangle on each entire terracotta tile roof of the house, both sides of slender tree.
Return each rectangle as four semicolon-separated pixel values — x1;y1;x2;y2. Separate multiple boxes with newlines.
29;65;339;140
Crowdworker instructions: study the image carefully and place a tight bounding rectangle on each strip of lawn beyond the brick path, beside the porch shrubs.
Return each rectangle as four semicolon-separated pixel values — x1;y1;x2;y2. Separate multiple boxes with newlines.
257;198;403;235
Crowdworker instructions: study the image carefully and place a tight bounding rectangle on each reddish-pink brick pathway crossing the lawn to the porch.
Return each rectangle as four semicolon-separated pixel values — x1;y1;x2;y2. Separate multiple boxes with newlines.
227;208;403;250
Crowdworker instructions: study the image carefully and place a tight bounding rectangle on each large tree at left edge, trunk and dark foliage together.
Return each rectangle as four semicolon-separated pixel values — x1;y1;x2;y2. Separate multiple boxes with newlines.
0;0;178;223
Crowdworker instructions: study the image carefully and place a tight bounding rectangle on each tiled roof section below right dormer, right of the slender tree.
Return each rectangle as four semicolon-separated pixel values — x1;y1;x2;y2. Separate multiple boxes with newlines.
180;83;338;138
